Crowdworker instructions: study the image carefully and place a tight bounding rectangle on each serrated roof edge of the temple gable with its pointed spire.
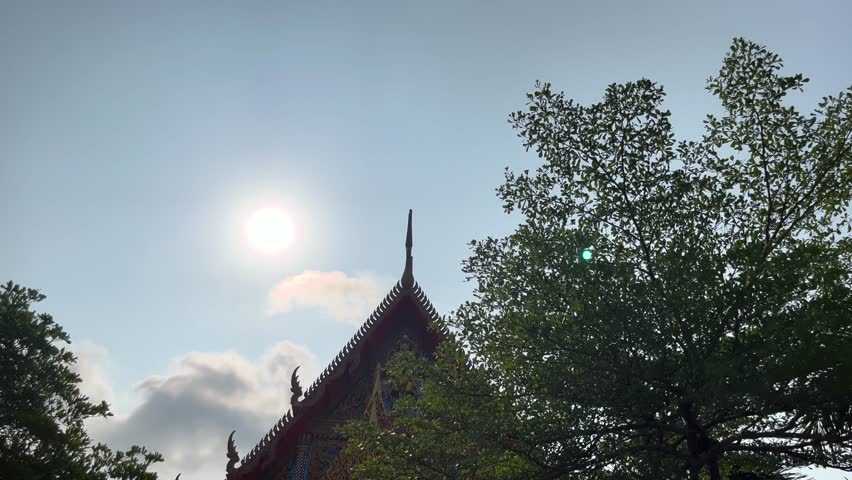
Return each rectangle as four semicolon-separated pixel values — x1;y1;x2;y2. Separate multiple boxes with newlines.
227;210;450;480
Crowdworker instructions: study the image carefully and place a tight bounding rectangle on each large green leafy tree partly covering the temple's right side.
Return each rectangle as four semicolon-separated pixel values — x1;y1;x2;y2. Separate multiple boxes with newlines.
347;39;852;480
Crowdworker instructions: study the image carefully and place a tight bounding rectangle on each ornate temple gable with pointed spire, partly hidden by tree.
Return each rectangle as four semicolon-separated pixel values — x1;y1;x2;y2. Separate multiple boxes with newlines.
226;210;447;480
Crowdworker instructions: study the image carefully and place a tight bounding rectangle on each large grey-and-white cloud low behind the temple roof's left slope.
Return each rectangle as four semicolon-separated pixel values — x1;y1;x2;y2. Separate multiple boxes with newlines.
89;341;318;480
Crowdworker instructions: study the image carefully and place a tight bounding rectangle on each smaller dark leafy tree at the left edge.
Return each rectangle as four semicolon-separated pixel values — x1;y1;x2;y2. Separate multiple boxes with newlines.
0;282;163;480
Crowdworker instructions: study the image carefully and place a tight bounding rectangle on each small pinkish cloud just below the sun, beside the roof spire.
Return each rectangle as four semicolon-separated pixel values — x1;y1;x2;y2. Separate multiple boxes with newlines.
268;270;387;325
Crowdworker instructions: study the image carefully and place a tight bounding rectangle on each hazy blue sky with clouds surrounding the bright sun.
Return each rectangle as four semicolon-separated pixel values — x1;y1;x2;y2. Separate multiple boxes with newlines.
0;0;852;480
